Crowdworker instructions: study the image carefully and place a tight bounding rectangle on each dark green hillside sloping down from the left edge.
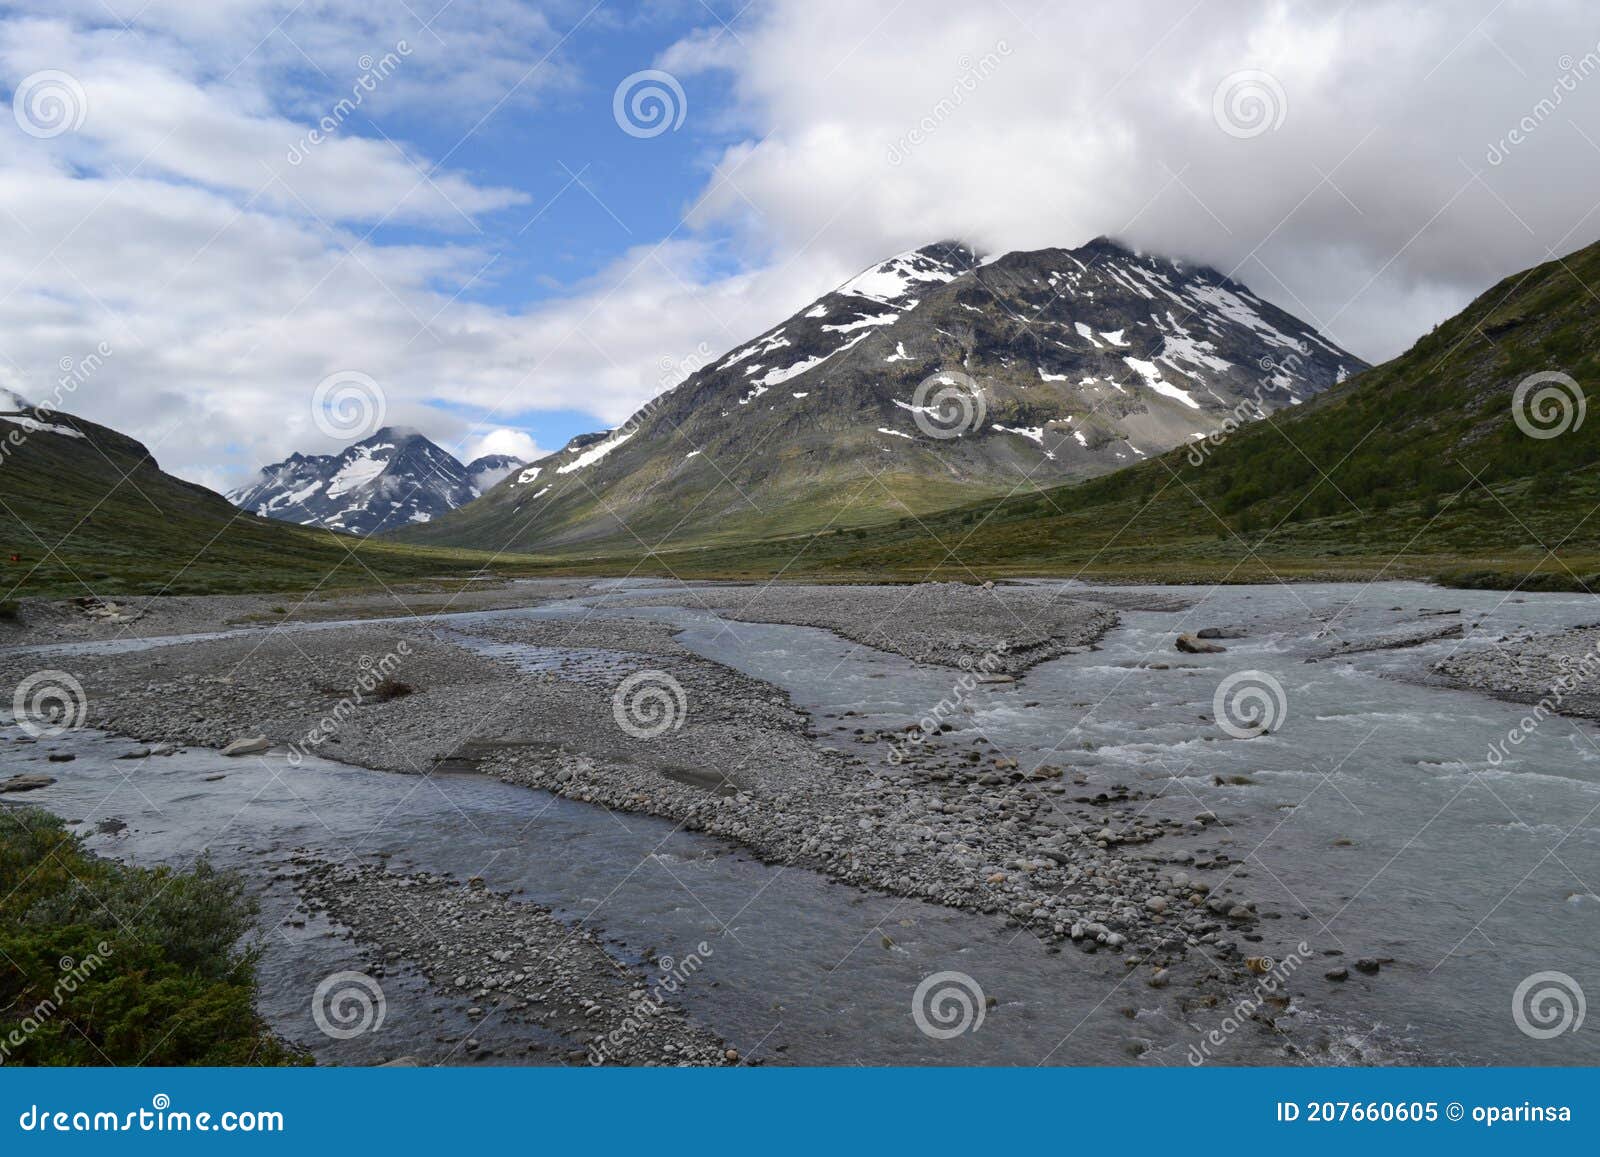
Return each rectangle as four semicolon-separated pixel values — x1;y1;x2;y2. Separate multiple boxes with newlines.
0;398;517;598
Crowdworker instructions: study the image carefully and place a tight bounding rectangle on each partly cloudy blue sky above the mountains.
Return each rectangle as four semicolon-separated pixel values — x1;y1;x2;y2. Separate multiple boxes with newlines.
0;0;1600;488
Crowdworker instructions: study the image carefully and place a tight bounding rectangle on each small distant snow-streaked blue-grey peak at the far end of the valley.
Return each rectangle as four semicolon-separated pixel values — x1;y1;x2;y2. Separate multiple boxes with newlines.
227;426;522;534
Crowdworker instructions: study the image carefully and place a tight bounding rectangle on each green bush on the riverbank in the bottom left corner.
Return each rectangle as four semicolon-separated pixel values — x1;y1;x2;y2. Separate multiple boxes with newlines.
0;808;307;1064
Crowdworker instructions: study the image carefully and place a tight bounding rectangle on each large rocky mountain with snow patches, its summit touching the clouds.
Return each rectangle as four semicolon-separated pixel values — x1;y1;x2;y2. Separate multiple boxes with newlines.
402;238;1365;552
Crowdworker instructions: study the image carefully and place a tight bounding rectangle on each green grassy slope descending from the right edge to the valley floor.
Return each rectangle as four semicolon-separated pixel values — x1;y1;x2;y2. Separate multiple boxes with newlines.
569;233;1600;592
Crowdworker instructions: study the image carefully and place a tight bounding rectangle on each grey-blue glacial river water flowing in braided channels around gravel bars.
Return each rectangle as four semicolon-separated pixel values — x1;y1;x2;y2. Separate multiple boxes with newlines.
0;584;1600;1064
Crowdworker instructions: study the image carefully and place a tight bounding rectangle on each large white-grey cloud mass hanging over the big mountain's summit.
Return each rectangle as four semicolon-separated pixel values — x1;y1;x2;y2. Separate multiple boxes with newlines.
678;0;1600;357
